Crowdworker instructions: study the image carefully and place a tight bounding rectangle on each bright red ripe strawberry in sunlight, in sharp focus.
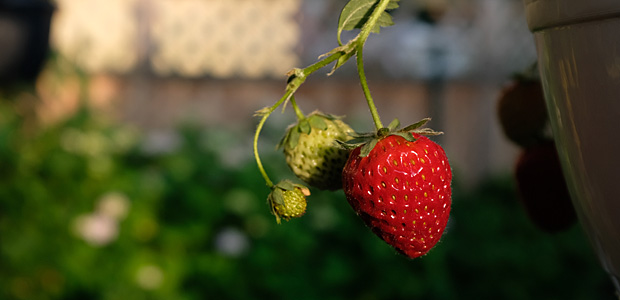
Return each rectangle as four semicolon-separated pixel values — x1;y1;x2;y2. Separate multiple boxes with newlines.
342;122;452;258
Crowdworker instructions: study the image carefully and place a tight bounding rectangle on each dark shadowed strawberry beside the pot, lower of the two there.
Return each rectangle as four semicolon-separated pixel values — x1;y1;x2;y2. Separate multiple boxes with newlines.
515;141;577;233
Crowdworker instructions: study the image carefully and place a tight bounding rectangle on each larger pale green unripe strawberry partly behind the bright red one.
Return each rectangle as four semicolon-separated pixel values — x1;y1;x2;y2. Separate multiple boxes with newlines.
279;112;353;190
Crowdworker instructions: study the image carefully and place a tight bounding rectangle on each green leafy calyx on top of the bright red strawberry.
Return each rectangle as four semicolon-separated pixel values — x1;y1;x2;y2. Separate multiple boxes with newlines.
338;118;443;157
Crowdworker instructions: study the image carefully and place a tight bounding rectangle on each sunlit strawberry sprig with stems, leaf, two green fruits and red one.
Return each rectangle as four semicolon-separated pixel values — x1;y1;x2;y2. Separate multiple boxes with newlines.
254;0;452;258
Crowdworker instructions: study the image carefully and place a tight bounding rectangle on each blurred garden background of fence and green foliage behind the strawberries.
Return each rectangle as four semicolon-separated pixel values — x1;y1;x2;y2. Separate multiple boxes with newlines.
0;0;615;300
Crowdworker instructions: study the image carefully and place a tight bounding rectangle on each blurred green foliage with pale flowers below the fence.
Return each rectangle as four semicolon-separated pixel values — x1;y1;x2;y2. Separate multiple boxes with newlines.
0;99;614;300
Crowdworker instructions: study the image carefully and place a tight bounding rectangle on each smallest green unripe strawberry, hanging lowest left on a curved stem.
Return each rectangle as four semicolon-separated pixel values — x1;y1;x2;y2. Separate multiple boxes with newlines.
267;180;310;224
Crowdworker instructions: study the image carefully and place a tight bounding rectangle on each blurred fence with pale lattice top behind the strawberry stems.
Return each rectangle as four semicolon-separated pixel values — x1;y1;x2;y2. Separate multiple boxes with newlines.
44;0;535;183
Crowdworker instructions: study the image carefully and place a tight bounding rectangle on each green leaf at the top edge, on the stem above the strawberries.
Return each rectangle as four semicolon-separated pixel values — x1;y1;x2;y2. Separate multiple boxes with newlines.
337;0;399;45
